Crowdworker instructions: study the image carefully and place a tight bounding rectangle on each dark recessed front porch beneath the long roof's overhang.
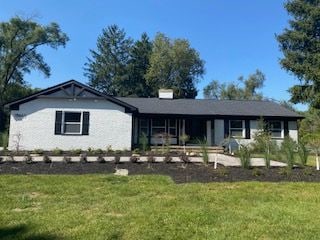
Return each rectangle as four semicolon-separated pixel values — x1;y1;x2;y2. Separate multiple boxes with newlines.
133;116;218;148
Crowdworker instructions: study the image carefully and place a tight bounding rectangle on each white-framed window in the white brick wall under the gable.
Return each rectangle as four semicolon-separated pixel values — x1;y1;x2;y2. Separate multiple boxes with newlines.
63;112;82;134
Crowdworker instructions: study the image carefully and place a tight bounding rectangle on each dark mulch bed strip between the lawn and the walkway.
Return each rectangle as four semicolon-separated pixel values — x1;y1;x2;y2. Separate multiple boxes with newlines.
0;162;320;183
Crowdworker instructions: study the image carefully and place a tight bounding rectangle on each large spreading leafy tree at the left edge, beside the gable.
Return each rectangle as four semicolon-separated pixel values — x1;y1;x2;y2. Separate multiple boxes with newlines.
0;17;68;130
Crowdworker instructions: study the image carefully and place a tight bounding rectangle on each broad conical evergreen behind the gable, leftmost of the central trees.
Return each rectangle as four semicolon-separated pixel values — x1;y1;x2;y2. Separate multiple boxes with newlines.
85;25;133;96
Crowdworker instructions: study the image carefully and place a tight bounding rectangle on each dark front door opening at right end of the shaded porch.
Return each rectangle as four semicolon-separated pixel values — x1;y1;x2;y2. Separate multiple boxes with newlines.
185;119;207;144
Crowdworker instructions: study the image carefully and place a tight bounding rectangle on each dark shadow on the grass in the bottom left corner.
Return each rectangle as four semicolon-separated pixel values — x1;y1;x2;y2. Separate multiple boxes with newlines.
0;224;65;240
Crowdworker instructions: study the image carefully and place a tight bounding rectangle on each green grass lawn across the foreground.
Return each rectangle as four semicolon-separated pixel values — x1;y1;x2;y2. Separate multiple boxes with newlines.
0;175;320;240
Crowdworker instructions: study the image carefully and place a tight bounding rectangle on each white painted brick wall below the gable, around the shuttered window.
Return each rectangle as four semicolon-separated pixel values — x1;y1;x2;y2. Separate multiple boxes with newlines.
9;99;132;150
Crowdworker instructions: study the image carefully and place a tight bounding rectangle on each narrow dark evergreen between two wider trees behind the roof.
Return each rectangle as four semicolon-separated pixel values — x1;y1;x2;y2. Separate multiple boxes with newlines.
126;33;152;97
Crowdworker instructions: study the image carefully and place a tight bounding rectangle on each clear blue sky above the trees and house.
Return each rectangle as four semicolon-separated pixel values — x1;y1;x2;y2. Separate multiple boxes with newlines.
0;0;305;110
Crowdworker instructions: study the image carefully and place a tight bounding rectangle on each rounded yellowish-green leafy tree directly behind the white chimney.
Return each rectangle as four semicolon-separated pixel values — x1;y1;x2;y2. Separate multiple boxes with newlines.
146;33;204;98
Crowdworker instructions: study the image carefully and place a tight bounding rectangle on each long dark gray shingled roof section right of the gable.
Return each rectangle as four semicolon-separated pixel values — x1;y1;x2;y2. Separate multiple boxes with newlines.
118;97;302;118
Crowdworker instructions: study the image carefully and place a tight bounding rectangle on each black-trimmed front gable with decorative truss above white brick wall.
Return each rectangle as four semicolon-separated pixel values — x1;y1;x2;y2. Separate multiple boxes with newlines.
6;80;137;112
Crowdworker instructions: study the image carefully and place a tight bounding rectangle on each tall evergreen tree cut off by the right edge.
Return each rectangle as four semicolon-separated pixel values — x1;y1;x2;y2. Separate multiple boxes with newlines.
277;0;320;108
